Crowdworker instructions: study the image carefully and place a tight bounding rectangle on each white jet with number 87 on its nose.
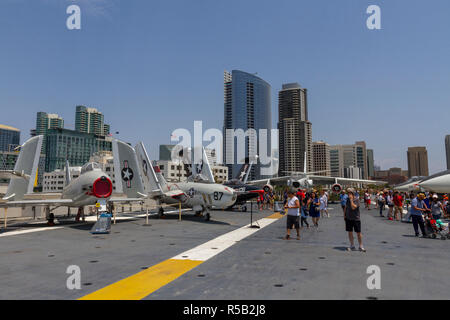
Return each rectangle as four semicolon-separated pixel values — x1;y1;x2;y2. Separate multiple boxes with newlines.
135;142;237;221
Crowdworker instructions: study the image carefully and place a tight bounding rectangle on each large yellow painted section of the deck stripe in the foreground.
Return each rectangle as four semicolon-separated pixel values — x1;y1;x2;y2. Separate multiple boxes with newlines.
79;259;203;300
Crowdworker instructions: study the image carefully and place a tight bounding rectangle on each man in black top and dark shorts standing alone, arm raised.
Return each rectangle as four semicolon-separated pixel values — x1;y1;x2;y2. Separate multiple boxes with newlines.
344;188;366;252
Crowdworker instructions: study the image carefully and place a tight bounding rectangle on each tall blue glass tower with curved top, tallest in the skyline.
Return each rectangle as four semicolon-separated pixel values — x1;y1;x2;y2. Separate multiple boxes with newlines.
223;70;272;180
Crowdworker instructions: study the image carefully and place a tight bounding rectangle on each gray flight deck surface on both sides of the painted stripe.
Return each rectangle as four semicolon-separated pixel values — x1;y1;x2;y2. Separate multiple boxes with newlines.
0;205;450;300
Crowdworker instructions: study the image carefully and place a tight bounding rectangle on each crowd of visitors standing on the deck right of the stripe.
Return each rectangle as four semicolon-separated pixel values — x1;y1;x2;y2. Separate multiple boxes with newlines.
284;188;450;252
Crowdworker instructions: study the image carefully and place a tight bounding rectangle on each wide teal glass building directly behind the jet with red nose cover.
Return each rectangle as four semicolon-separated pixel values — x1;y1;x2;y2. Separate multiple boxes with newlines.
45;129;112;172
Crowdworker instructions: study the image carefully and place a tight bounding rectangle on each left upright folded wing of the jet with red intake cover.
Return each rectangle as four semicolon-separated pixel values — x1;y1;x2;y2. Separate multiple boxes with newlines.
3;135;44;201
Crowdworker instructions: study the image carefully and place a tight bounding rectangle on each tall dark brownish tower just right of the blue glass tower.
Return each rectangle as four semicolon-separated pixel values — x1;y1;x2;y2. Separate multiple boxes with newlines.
278;83;313;176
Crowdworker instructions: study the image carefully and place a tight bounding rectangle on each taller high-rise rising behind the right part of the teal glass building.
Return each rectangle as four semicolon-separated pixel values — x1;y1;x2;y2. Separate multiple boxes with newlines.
75;106;110;136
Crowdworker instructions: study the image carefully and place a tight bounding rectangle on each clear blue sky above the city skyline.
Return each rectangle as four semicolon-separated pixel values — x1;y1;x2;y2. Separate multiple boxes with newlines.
0;0;450;172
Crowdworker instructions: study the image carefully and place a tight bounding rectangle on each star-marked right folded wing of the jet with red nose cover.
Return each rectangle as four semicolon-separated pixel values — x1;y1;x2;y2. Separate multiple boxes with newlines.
112;139;146;198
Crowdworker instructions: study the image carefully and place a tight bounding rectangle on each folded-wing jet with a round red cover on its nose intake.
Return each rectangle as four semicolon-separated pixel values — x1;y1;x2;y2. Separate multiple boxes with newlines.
0;135;146;223
